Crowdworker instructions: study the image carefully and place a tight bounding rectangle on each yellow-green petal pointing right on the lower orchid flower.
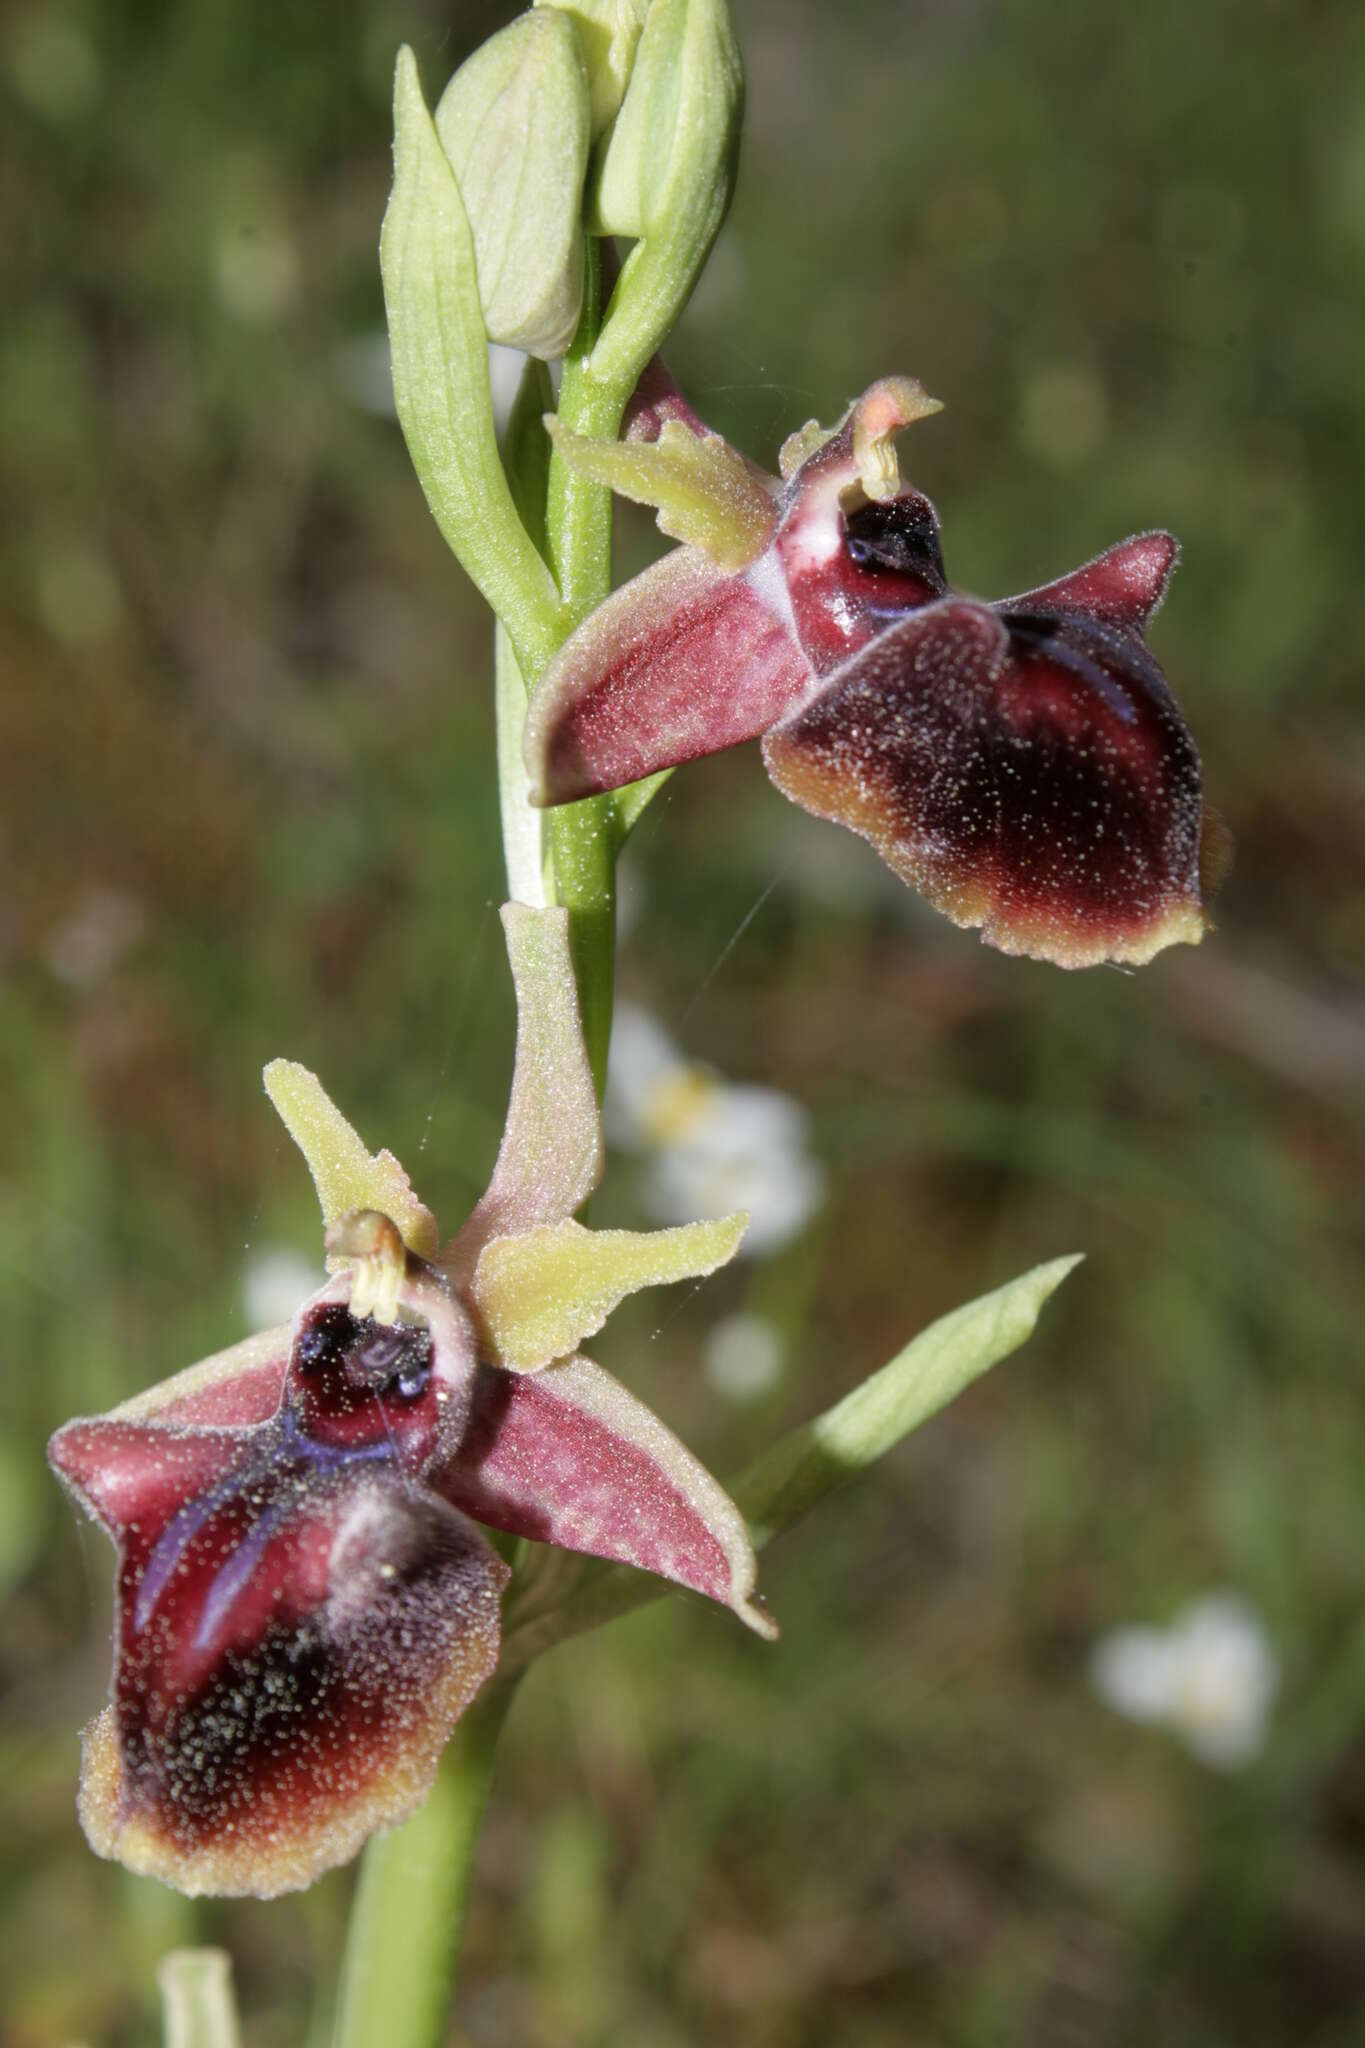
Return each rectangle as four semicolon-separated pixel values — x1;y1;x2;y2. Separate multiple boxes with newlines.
469;1214;749;1372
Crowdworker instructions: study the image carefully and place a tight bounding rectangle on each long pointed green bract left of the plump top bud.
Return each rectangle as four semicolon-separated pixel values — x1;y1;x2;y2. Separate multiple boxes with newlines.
379;49;563;670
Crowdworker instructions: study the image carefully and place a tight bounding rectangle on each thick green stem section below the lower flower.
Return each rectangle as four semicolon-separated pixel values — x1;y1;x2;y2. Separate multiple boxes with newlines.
334;1677;516;2048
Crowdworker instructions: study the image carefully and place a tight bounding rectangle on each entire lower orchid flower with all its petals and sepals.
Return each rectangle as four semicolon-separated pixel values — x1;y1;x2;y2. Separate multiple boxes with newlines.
49;905;776;1896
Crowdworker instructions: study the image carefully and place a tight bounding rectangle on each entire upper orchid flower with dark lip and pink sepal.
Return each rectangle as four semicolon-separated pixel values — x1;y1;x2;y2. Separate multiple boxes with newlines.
526;377;1224;967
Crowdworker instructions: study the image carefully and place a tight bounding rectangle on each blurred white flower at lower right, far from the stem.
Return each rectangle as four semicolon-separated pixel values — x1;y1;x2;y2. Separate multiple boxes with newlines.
1091;1593;1279;1769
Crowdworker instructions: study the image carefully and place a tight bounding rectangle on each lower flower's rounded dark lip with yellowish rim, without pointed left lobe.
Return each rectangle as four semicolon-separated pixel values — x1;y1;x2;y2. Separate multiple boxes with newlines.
84;1460;505;1892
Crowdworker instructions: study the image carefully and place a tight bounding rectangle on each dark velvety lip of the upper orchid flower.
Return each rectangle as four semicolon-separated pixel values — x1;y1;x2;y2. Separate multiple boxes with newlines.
765;600;1203;967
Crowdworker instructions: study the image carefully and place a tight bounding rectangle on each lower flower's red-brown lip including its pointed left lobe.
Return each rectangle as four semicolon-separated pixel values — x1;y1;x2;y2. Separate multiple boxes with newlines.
53;1384;505;1894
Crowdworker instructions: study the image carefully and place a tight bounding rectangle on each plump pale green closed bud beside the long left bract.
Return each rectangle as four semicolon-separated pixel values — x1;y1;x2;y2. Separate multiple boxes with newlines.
436;8;589;356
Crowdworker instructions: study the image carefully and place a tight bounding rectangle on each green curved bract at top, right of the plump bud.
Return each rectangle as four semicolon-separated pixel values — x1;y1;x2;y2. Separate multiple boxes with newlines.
589;0;745;389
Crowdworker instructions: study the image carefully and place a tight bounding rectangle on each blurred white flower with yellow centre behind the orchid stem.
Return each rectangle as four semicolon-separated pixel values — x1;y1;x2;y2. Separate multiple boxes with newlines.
604;1004;825;1257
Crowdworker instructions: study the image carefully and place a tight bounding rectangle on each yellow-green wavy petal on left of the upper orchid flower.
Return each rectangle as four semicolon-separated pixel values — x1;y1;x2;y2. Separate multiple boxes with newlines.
544;414;778;569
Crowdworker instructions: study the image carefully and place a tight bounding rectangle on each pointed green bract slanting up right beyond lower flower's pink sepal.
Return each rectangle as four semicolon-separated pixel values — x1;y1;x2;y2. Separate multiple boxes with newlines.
731;1253;1081;1548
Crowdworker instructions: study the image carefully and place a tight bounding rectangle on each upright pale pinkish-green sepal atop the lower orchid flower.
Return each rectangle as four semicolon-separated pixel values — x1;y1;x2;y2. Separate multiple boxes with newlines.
446;903;602;1284
